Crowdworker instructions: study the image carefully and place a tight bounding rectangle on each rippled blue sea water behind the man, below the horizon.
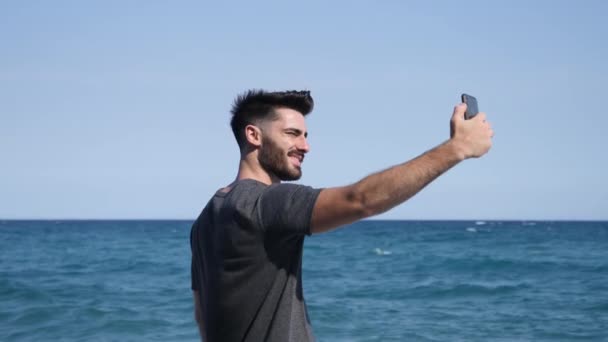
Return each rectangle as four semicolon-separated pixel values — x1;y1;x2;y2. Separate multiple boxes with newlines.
0;221;608;342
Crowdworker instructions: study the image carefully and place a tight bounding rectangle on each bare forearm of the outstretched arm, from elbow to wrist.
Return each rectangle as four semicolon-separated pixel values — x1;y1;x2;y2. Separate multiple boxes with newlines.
351;140;464;217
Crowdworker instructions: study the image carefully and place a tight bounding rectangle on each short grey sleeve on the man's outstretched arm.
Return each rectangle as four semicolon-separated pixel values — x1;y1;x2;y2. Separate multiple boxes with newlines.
258;183;321;235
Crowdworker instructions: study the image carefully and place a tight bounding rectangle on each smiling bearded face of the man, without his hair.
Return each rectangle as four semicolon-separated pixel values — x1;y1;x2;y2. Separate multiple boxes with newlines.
258;108;310;181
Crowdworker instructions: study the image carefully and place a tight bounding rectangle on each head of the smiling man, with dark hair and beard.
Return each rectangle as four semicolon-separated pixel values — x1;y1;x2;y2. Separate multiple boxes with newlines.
230;90;314;180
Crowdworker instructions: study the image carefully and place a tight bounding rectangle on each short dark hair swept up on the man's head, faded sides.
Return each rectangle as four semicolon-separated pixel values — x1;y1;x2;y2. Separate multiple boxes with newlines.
230;89;314;149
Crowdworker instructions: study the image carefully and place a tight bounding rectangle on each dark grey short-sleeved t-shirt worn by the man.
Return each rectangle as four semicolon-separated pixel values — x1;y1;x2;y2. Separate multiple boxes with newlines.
190;179;321;342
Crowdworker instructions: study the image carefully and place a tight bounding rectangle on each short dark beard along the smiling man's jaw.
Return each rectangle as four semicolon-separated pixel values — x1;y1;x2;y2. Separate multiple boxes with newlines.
258;137;302;181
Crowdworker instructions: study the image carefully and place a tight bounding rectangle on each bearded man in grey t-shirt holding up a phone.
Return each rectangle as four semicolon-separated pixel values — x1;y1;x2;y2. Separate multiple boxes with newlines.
190;90;493;342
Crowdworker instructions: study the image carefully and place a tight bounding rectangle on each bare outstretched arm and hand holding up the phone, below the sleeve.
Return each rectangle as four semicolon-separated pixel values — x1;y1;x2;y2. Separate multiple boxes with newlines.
312;103;494;233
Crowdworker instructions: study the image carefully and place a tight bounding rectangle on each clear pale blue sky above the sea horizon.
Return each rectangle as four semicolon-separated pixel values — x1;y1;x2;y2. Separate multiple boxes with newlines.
0;1;608;220
